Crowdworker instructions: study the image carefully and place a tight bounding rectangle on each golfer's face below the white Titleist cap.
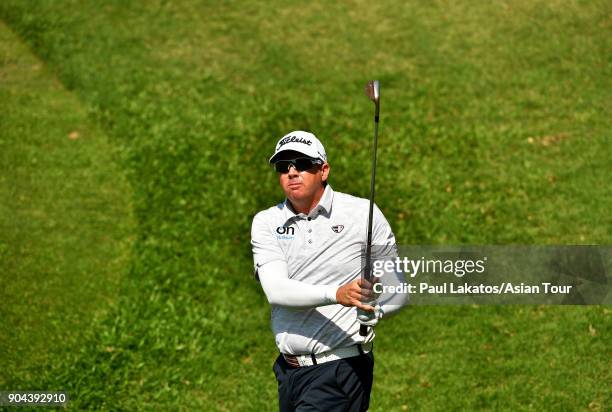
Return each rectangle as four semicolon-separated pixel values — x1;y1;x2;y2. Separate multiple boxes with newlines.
278;152;329;203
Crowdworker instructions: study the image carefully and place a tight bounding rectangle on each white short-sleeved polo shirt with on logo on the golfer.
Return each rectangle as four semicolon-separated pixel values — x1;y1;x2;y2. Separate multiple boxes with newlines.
251;185;397;355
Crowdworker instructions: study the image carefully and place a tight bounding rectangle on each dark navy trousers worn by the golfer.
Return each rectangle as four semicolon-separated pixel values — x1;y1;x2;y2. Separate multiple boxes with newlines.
272;352;374;412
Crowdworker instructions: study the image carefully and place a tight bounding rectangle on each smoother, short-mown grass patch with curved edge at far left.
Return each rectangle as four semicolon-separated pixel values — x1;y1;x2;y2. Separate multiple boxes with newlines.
0;22;133;390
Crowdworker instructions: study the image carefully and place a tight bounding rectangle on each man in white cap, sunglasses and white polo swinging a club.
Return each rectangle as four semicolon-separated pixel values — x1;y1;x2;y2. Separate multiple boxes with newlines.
251;131;405;412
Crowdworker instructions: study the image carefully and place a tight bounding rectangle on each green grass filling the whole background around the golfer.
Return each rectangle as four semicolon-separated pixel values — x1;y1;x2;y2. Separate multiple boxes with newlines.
0;0;612;411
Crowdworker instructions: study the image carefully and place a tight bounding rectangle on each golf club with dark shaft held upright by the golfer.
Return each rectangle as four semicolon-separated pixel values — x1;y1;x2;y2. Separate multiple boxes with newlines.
357;80;380;336
